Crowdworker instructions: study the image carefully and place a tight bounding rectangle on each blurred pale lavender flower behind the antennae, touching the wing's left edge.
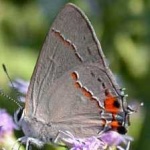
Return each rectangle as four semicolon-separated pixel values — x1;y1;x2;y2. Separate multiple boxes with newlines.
10;78;29;102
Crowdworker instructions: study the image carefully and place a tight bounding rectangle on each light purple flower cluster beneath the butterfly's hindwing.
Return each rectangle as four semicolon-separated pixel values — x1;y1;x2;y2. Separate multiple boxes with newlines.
62;131;132;150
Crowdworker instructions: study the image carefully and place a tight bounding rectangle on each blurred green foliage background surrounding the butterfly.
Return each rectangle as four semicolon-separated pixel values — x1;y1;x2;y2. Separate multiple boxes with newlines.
0;0;150;150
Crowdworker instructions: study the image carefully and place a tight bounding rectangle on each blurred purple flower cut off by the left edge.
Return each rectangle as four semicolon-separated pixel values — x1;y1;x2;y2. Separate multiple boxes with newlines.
0;109;16;141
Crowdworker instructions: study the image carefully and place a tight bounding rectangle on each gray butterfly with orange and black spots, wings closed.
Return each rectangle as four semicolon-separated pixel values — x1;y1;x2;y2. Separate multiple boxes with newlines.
15;4;132;149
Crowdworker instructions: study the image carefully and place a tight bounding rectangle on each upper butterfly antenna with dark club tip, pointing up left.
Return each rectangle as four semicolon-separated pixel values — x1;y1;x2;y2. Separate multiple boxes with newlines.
2;64;21;104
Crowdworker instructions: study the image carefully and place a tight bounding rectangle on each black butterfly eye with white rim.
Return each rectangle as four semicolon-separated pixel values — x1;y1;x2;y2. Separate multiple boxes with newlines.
14;108;24;126
